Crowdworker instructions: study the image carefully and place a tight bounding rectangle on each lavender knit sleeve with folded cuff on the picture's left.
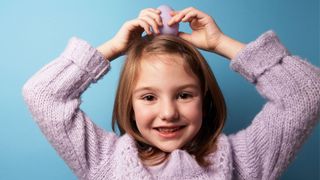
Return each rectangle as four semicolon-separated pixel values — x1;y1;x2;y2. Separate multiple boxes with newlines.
23;38;117;179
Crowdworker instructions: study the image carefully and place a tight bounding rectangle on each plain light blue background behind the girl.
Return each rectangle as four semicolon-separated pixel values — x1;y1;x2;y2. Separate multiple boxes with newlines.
0;0;320;180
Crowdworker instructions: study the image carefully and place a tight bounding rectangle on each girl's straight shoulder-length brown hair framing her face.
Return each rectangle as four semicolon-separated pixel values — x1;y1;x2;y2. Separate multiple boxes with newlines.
112;35;227;167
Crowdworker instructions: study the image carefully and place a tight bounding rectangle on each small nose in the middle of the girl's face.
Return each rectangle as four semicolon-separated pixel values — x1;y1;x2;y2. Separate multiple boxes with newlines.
159;100;179;121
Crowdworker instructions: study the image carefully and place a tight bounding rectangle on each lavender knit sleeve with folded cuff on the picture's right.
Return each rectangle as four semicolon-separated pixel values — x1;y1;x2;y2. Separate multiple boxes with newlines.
229;31;320;179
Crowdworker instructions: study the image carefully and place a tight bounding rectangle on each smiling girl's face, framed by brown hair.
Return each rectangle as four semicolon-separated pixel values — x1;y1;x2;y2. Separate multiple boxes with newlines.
132;55;202;152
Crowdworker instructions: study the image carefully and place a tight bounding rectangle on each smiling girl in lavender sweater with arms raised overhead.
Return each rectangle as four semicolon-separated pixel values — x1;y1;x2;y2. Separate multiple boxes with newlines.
23;8;320;180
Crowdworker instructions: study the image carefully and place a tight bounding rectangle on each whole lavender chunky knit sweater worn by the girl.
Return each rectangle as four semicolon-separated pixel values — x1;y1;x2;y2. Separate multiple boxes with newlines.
23;31;320;180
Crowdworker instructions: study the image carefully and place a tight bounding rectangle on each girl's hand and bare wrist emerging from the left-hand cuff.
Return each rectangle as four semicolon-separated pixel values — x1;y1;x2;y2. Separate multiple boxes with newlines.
97;8;162;61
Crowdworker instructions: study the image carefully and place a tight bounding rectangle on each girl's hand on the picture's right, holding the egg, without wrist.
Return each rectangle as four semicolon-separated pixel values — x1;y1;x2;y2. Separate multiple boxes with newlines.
168;7;223;52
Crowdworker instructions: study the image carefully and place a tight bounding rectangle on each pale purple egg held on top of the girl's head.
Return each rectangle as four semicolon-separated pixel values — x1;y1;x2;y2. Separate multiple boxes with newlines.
157;5;179;36
